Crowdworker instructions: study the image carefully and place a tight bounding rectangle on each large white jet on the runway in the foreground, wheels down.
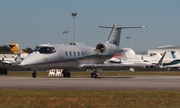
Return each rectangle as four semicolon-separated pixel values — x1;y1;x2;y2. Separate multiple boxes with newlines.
21;24;146;78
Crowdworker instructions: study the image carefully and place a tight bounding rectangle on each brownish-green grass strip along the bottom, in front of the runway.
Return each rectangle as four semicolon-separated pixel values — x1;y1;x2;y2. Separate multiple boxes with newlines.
0;90;180;108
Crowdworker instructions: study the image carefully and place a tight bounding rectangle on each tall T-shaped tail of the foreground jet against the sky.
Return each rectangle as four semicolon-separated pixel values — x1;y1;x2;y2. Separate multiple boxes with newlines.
99;23;147;46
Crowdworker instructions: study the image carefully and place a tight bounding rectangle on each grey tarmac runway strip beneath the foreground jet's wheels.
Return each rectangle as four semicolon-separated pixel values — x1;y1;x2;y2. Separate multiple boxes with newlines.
0;76;180;91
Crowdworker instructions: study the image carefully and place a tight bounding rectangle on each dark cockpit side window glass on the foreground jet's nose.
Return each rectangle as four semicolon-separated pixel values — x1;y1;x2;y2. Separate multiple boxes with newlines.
37;47;56;54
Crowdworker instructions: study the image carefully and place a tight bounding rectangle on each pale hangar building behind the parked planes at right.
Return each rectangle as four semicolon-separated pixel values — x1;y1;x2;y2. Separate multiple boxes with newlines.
147;45;180;56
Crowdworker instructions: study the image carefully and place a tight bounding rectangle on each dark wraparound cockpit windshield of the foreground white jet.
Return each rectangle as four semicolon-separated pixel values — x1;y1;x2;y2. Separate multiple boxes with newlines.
34;46;56;54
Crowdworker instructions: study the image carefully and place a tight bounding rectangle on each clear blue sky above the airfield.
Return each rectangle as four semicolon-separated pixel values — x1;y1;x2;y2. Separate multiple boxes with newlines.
0;0;180;52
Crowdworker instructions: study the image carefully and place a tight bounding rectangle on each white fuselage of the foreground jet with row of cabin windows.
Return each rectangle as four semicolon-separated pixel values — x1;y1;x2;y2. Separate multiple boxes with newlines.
21;44;113;69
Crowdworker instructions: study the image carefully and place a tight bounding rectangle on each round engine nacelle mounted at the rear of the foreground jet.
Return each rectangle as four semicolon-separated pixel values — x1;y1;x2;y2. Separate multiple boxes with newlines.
95;43;118;55
